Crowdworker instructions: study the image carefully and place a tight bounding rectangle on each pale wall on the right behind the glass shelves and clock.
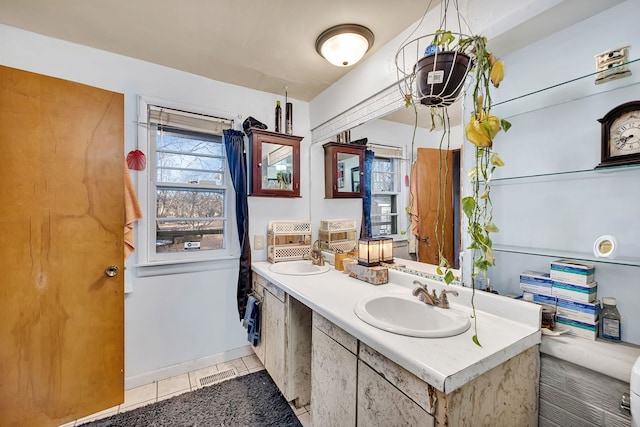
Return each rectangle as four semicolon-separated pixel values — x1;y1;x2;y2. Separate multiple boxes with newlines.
490;0;640;344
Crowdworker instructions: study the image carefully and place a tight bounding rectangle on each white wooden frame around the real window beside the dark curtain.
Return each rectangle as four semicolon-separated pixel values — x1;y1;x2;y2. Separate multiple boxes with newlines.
136;96;240;266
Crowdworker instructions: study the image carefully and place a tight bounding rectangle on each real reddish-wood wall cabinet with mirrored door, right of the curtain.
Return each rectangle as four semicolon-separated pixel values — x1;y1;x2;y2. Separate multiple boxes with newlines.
247;128;303;197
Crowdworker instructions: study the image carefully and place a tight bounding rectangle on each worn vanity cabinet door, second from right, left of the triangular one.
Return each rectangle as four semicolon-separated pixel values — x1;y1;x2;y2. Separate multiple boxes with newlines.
311;324;356;427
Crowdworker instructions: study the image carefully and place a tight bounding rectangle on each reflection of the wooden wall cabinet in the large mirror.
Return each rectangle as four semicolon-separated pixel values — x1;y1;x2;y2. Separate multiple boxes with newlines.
322;142;366;199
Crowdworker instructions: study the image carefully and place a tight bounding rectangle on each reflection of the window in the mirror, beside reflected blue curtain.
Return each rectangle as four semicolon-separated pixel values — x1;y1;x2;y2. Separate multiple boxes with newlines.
369;146;402;236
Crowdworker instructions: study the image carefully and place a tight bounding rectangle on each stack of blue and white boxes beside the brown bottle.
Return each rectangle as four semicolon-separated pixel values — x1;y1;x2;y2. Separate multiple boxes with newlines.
520;259;600;340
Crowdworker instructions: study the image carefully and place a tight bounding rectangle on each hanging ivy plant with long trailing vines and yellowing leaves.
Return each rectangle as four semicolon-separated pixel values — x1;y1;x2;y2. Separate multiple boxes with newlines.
396;25;511;345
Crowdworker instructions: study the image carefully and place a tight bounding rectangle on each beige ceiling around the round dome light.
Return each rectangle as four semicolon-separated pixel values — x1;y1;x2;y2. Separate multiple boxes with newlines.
0;0;439;101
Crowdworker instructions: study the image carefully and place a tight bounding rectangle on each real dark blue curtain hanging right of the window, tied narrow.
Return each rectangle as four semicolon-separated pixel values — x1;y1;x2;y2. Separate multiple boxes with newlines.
224;129;251;320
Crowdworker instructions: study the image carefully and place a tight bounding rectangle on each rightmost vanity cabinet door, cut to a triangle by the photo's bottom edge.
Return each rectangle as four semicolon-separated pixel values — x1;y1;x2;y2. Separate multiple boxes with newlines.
357;361;435;427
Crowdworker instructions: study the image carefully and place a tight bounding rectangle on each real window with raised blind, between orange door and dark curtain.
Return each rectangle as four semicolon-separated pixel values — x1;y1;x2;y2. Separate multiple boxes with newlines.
140;104;235;262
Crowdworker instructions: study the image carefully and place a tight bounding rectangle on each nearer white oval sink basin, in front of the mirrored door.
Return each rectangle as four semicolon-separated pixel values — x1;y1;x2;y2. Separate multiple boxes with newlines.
353;294;471;338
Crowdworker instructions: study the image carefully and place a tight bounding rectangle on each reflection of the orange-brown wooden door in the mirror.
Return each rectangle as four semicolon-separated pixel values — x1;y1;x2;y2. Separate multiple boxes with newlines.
414;148;460;268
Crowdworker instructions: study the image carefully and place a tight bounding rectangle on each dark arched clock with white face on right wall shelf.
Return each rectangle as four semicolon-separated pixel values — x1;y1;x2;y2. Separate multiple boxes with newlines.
596;101;640;168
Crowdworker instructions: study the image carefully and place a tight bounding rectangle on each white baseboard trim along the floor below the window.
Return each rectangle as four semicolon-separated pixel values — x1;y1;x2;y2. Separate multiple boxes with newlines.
124;345;253;390
